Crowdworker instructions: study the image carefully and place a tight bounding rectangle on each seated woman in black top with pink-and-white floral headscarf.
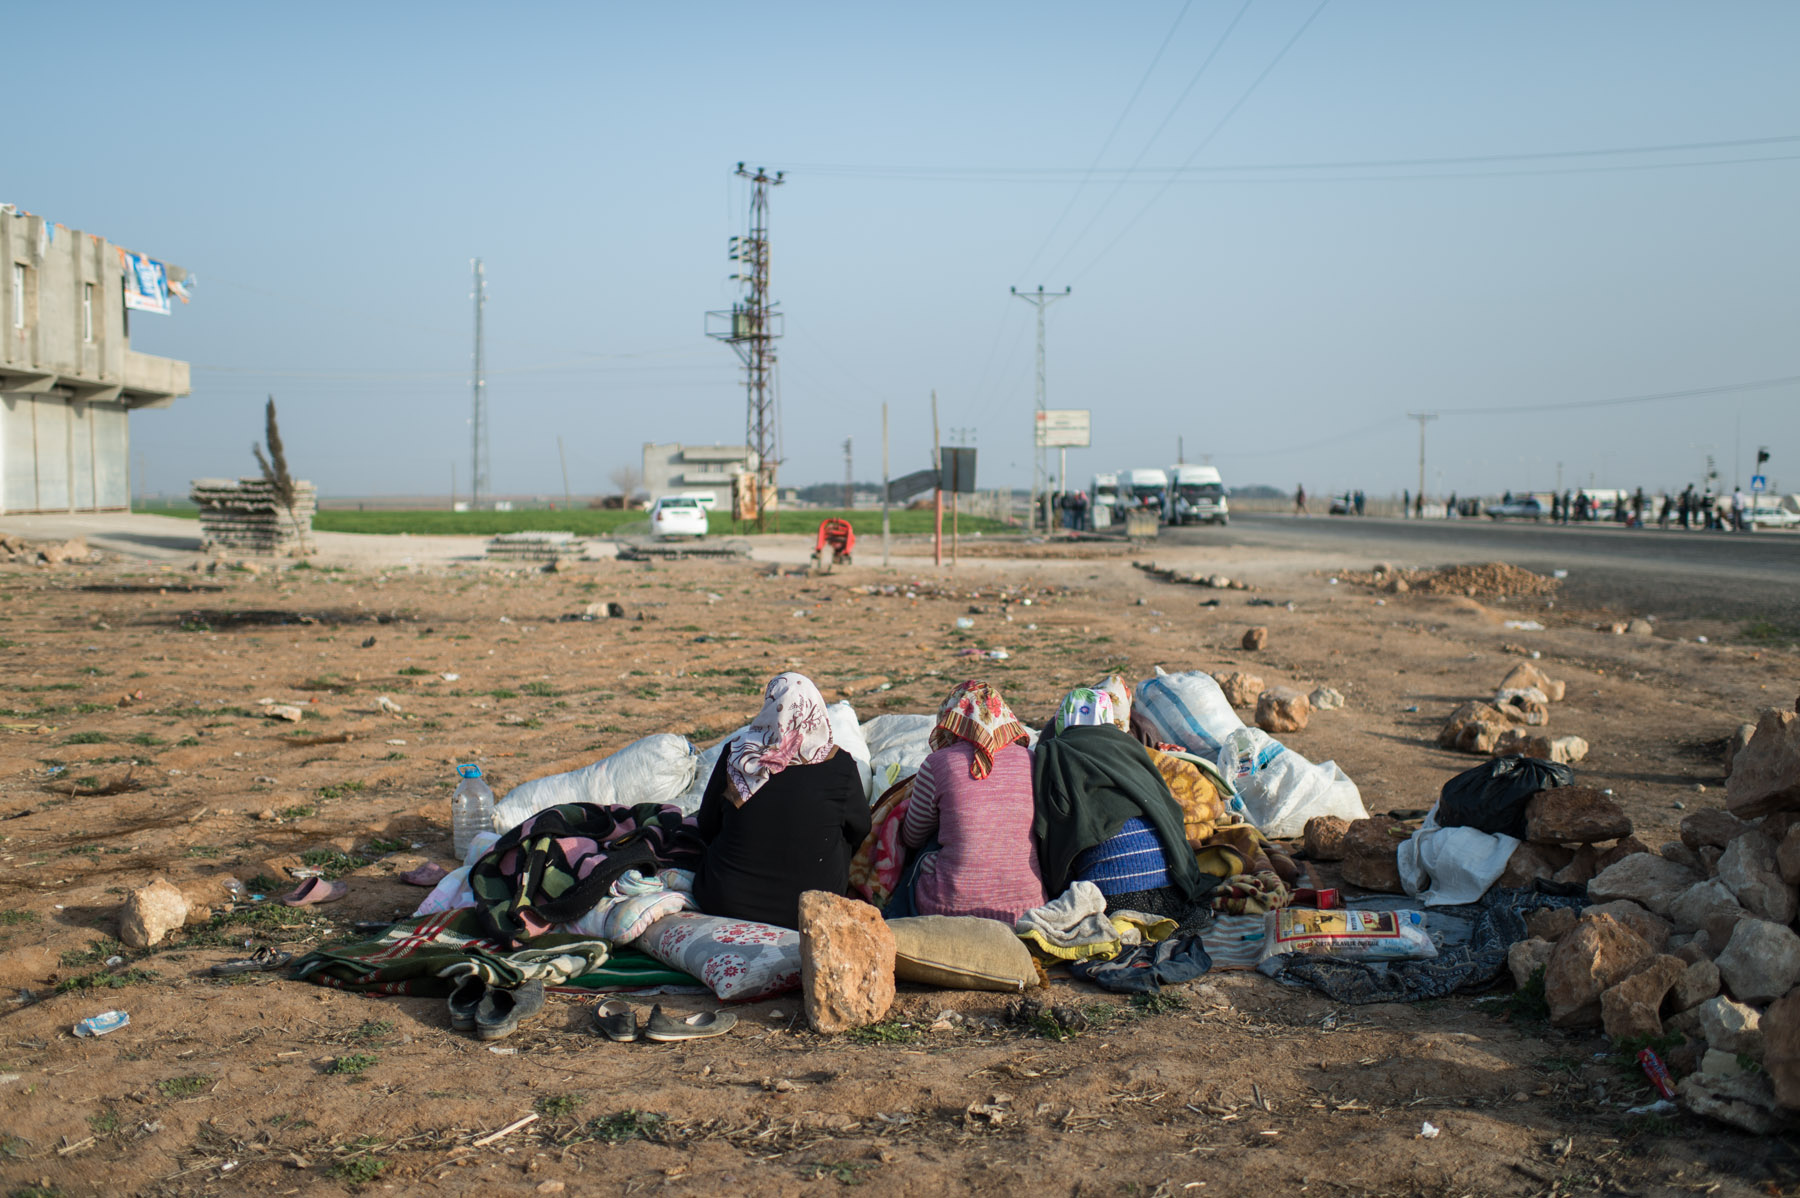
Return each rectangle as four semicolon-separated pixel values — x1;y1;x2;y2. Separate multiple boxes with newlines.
693;673;869;928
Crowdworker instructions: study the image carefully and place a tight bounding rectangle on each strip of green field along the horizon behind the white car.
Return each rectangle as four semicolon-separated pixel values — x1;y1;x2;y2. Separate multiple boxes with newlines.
139;505;1017;538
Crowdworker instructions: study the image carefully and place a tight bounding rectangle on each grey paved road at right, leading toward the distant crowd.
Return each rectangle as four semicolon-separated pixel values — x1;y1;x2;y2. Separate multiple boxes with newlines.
1163;514;1800;635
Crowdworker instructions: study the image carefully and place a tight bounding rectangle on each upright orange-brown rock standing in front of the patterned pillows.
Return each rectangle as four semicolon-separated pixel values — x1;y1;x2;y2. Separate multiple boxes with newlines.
799;890;895;1033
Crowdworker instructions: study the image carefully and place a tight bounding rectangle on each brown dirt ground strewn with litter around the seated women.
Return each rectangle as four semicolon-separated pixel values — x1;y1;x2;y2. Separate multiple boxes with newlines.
0;543;1800;1196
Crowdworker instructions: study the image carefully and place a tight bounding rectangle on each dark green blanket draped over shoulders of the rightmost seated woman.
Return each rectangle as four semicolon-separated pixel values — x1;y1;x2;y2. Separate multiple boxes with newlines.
1031;725;1202;901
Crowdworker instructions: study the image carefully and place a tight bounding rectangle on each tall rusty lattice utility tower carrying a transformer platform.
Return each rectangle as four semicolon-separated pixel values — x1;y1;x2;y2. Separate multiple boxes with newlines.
706;162;785;529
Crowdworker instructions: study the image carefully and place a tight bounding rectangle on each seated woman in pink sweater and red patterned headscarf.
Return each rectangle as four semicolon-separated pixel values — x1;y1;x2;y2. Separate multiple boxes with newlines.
900;682;1044;926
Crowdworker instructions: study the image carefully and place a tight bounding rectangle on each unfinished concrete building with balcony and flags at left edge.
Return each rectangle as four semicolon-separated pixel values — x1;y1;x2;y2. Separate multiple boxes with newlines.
0;203;189;513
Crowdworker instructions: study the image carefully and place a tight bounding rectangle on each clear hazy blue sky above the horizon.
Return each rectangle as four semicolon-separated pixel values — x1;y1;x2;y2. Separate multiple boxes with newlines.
14;0;1800;496
